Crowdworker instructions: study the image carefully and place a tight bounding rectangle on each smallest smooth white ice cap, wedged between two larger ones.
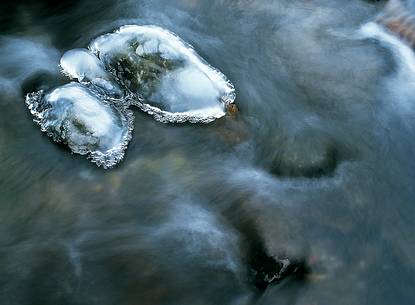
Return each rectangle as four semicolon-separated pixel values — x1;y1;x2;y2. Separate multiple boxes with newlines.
60;49;122;97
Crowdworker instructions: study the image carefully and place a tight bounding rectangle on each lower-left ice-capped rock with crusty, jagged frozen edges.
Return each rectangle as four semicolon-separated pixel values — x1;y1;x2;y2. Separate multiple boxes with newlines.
26;83;133;168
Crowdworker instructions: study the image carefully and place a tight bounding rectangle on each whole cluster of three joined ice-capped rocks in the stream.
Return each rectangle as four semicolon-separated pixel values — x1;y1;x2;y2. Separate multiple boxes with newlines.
26;25;235;168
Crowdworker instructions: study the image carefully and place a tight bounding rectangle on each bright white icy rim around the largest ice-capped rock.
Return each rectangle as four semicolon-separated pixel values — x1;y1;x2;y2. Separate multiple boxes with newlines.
89;25;236;123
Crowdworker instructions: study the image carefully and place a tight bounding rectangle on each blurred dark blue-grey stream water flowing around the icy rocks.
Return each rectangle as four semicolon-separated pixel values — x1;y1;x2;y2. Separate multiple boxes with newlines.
0;0;415;305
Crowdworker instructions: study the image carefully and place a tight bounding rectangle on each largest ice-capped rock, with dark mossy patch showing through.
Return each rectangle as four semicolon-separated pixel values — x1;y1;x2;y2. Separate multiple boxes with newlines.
90;25;235;123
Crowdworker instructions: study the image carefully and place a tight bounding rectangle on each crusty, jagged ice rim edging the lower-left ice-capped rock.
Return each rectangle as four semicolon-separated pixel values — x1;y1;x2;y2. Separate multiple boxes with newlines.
25;90;134;169
